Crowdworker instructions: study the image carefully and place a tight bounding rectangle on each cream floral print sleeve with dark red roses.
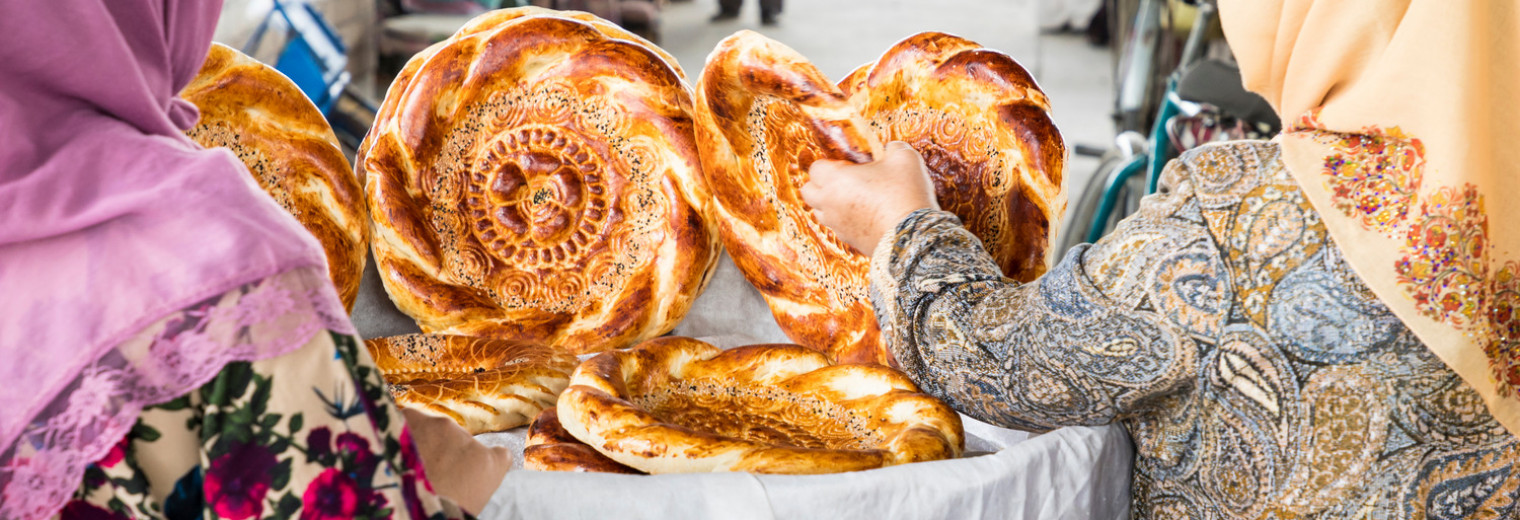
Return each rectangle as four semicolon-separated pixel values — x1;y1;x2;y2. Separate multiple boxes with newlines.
61;333;467;520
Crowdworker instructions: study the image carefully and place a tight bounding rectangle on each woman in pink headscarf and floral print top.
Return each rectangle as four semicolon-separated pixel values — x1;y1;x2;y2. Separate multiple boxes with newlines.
0;0;506;518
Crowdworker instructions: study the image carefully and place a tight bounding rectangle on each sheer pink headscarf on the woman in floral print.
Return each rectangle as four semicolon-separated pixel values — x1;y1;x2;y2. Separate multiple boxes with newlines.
0;0;340;518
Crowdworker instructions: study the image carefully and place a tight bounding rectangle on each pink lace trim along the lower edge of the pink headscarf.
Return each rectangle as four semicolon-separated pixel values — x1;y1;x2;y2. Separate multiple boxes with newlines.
0;268;354;520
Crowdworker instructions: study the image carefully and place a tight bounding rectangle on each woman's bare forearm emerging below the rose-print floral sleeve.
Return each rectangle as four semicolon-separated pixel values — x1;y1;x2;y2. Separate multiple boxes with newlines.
401;407;512;514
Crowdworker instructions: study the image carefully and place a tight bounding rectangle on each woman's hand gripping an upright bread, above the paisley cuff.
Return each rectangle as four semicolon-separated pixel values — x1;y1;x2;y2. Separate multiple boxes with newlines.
803;141;939;255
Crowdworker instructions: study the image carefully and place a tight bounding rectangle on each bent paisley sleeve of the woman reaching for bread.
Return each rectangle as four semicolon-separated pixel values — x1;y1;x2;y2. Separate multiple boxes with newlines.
871;163;1228;432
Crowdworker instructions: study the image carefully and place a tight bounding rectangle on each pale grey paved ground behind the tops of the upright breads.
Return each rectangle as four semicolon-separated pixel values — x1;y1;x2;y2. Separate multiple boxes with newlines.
660;0;1114;221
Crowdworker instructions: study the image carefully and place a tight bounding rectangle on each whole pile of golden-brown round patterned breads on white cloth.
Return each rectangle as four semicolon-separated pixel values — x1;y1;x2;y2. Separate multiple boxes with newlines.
185;8;1064;473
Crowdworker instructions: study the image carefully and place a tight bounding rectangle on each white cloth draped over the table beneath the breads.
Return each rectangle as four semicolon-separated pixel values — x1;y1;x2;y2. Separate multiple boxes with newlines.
353;254;1134;520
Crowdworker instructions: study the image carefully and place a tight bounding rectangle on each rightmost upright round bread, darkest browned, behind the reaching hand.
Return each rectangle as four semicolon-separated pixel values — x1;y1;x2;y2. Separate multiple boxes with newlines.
839;32;1066;281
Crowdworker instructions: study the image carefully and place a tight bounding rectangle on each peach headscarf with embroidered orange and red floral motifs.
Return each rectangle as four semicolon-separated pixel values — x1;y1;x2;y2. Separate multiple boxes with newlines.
1219;0;1520;433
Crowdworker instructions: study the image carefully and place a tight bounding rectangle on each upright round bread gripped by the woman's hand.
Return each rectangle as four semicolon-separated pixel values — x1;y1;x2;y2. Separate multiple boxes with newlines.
696;30;891;362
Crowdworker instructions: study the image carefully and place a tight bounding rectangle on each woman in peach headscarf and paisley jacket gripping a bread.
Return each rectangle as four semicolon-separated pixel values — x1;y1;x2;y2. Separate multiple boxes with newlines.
804;0;1520;518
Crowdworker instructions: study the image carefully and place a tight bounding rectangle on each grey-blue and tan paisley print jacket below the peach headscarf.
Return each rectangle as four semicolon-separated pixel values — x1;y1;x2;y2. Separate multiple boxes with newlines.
871;141;1520;518
